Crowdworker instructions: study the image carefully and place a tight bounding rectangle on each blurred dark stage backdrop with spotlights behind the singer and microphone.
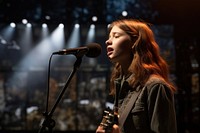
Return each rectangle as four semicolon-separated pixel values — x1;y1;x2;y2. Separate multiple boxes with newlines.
0;0;200;133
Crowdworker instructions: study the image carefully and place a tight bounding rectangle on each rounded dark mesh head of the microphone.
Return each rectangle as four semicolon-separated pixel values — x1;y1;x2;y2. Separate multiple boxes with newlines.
85;43;102;58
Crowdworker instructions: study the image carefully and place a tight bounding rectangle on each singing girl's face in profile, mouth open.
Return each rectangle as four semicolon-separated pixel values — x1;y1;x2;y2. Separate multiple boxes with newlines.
106;26;133;65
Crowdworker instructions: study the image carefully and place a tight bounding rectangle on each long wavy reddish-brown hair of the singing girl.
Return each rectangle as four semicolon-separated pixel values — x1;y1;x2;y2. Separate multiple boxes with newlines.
108;19;176;94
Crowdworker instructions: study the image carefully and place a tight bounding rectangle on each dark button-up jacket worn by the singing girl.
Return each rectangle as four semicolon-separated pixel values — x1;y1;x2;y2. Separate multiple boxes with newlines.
115;77;177;133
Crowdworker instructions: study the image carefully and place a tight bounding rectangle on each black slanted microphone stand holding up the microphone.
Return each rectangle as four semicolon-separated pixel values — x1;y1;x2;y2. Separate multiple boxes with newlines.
38;56;82;133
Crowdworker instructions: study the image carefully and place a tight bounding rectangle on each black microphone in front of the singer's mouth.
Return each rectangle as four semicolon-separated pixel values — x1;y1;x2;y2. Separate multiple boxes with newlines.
53;43;102;58
